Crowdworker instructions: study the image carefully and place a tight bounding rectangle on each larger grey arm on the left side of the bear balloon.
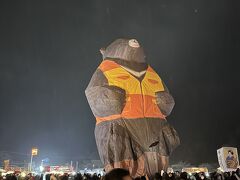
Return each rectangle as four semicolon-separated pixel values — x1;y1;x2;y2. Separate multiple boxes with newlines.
85;69;125;117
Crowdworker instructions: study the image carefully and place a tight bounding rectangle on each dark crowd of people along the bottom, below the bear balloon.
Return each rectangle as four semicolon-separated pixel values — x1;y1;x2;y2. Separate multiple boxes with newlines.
0;168;240;180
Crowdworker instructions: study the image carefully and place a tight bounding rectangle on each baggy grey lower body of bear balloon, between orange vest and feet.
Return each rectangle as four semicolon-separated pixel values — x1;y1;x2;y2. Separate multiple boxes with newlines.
95;118;180;165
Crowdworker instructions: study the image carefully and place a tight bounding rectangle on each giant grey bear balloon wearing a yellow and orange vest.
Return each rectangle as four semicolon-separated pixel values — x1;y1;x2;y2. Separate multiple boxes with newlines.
85;39;180;177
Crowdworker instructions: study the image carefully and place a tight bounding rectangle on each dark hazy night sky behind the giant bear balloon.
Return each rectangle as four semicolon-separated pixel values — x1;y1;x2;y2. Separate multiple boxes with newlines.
0;0;240;164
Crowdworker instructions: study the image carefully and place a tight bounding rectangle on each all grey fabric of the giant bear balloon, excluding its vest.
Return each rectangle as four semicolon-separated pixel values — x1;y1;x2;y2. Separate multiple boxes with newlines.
85;39;180;175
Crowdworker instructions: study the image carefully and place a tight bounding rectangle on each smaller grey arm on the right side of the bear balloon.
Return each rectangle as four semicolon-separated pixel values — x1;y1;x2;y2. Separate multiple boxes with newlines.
156;82;175;116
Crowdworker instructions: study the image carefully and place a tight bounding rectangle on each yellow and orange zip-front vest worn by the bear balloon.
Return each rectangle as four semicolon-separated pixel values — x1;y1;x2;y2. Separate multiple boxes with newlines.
96;60;165;123
